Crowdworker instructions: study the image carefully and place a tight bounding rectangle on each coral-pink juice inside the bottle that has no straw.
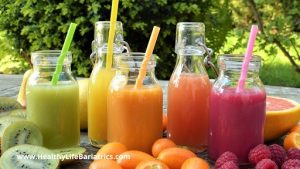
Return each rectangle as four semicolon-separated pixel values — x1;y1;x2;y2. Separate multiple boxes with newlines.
167;73;211;150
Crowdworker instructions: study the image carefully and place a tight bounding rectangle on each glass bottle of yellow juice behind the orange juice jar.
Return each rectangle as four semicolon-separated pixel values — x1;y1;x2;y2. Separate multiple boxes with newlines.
88;21;123;147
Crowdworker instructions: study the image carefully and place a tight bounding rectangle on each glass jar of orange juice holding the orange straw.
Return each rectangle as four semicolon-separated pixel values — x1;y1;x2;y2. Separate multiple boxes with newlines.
107;53;163;153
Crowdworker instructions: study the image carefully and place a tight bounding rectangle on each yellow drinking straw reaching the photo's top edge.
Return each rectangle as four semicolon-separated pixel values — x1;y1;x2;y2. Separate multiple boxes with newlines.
106;0;119;69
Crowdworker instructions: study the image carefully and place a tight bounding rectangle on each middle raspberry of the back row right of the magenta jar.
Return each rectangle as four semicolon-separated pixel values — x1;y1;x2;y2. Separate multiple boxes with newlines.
269;144;286;166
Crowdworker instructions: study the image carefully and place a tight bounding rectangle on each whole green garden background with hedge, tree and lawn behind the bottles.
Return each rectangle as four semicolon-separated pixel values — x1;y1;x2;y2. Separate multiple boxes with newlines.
0;0;300;87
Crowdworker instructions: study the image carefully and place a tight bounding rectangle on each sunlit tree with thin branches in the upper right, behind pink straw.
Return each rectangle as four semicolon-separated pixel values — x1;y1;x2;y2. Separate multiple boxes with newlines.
227;0;300;73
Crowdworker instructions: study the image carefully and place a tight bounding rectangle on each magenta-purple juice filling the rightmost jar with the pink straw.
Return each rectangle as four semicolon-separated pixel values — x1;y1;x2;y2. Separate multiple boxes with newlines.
208;88;266;163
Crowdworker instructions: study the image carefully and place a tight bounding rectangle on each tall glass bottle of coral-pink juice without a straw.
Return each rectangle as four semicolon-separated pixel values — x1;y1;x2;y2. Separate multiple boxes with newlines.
167;22;211;151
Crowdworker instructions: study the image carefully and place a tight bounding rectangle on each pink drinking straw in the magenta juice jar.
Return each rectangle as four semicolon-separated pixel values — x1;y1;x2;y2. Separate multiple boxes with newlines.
237;25;258;92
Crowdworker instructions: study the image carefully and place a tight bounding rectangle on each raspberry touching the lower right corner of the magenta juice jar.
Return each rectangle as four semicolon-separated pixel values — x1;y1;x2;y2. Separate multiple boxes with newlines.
248;144;271;165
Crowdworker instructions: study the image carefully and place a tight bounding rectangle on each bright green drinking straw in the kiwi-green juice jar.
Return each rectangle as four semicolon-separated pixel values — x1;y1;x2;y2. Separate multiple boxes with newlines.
51;23;77;85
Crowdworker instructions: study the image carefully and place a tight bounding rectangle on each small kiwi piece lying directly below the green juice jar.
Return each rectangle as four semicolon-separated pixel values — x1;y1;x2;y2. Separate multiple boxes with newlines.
52;146;86;165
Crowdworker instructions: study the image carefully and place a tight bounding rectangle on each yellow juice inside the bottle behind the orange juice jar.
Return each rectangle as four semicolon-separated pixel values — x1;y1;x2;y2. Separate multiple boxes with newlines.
88;66;115;147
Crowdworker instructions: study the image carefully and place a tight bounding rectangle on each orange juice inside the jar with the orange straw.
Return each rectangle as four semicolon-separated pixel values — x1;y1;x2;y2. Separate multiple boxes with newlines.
107;85;163;153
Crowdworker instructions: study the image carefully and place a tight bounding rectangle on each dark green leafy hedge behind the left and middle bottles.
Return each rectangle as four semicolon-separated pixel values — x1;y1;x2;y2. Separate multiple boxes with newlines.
0;0;232;79
